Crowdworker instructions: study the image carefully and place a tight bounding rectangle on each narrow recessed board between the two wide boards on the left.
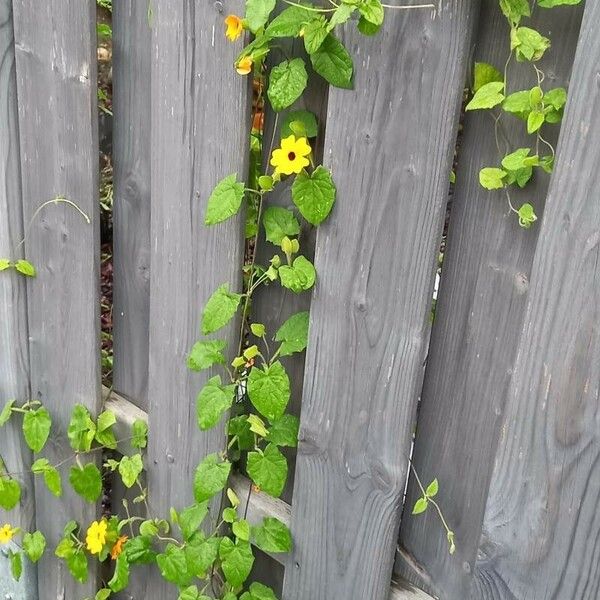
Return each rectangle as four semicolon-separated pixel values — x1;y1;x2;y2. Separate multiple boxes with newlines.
113;0;152;410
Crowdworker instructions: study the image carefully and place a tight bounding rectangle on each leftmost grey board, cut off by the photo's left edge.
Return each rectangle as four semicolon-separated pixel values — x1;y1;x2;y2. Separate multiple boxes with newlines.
0;0;37;600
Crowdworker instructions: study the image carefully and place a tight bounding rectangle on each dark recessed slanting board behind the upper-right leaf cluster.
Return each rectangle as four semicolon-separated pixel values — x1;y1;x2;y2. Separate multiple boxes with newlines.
396;0;581;599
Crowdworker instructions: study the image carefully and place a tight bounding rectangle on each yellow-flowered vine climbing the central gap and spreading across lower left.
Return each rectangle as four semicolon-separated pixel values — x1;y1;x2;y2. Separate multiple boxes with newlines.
0;0;460;600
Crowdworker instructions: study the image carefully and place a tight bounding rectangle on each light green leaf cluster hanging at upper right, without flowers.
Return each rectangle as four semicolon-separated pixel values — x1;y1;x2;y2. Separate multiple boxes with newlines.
466;0;581;228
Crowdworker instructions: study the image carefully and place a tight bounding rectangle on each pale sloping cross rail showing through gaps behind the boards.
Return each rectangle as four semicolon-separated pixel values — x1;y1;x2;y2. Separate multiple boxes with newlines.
103;387;434;600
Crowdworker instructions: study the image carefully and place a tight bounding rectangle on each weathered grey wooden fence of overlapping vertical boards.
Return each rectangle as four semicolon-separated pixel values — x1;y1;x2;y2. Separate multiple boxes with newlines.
0;0;600;600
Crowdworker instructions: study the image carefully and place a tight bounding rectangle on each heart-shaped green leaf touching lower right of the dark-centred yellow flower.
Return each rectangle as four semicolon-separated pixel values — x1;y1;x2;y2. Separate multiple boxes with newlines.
292;166;336;225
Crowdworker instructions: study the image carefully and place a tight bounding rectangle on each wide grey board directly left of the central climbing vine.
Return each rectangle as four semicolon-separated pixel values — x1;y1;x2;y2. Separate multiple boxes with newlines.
148;0;250;599
